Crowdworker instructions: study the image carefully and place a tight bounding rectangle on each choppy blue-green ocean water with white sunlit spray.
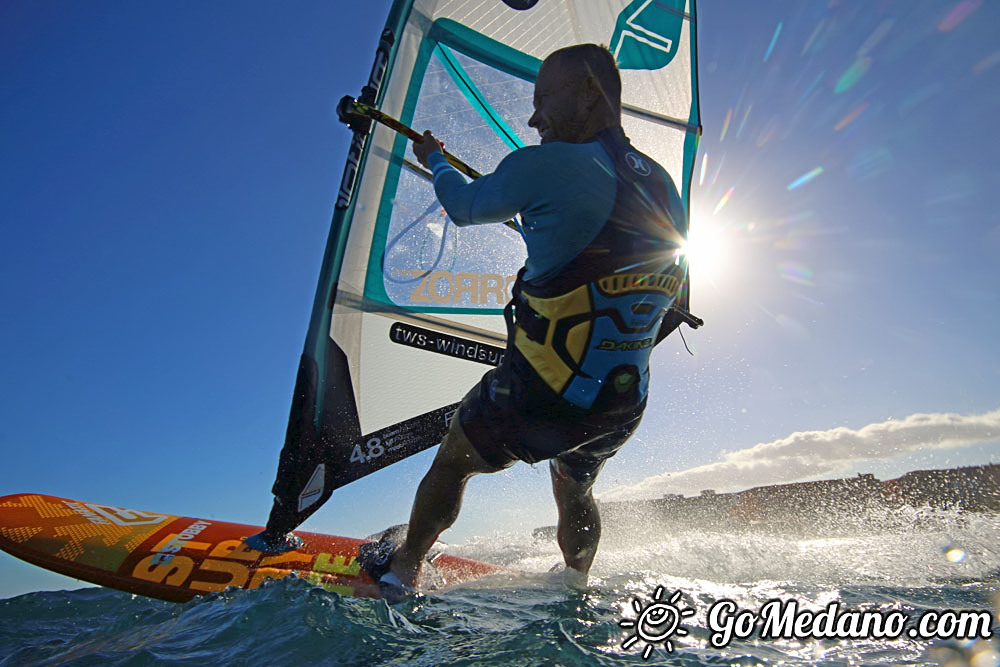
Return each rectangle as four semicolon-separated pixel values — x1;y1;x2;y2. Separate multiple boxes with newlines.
0;510;1000;667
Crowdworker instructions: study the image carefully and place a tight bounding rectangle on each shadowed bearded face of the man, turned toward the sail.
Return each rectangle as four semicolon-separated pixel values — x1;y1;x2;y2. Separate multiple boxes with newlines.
528;59;589;144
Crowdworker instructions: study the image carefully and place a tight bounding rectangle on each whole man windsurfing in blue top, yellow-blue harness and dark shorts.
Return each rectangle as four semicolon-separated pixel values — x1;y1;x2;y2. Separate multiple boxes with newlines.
362;44;686;590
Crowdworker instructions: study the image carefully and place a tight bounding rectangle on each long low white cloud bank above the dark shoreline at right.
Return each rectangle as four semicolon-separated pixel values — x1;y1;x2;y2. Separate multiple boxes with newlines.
600;409;1000;501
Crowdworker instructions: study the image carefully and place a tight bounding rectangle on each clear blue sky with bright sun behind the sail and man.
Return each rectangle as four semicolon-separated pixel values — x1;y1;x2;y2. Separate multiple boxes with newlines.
0;0;1000;598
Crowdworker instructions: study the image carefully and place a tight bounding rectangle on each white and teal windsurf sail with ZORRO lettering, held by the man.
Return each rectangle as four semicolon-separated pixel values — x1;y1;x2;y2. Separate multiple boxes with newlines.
267;0;700;535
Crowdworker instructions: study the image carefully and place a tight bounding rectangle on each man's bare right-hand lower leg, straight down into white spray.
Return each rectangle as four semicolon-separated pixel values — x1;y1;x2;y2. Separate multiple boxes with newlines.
549;459;601;581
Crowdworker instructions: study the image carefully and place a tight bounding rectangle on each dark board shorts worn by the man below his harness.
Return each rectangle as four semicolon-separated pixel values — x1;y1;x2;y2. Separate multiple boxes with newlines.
458;350;646;483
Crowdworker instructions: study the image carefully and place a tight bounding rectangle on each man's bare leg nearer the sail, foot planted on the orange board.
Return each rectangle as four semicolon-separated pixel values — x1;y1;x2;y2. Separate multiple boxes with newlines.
390;422;503;586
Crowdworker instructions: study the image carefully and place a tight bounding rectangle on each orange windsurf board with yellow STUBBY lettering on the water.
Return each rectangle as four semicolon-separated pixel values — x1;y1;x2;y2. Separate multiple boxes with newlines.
0;493;506;602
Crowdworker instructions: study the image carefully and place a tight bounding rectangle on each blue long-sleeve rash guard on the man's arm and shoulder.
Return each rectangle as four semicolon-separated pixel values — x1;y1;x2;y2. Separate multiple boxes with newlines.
428;141;616;280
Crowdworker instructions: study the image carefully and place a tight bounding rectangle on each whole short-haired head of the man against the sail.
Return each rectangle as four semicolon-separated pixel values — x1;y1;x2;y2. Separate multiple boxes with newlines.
528;44;622;144
